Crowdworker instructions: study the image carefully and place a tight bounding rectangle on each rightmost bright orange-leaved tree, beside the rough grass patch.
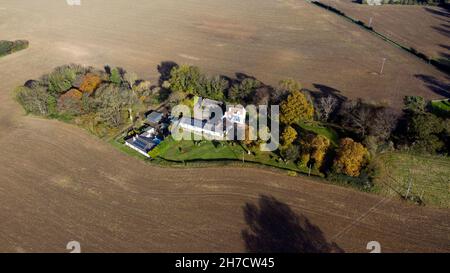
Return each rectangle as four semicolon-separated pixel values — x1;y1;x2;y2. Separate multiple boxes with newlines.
334;138;369;177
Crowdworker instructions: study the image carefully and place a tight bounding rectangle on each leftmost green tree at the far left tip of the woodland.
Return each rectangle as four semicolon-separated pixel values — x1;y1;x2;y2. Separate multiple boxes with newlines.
15;86;51;116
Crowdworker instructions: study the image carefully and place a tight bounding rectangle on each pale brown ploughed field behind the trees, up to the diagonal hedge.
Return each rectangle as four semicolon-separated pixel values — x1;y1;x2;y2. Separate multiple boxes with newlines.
0;0;449;106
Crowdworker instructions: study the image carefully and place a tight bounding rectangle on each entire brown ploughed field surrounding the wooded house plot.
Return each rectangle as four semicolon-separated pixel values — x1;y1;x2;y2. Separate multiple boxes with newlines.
0;0;450;252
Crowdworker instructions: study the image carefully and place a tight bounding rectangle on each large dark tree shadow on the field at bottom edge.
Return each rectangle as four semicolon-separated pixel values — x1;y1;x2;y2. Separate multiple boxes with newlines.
242;195;344;253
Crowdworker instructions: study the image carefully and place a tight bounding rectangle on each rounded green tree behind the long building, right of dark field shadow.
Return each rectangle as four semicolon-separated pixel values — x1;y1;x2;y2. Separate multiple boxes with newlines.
169;65;201;94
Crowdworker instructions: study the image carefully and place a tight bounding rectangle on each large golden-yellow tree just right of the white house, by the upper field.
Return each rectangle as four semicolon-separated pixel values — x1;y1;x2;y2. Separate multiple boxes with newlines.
280;91;314;125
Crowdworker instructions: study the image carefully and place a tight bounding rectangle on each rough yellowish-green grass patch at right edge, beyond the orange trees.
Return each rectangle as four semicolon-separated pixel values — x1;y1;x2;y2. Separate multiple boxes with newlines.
374;152;450;208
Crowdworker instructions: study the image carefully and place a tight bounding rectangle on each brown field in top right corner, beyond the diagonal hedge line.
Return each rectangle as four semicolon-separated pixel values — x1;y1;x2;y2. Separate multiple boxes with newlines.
320;0;450;59
